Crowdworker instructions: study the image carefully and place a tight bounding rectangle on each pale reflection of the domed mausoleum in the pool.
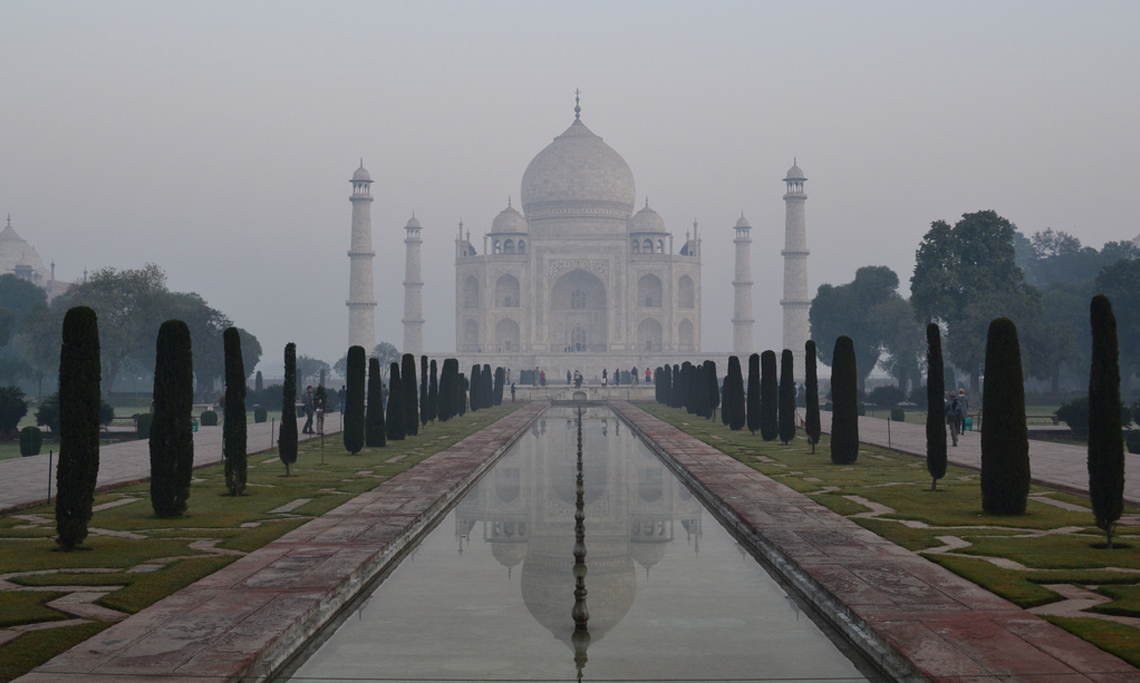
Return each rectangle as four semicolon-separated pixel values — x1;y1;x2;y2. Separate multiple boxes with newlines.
455;408;701;645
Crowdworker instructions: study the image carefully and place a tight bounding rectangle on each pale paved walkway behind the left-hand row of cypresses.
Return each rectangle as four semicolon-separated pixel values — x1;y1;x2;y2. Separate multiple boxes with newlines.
0;413;341;512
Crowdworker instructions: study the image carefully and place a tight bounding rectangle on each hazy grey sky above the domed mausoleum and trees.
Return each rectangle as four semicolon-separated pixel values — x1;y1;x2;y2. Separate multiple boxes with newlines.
0;0;1140;376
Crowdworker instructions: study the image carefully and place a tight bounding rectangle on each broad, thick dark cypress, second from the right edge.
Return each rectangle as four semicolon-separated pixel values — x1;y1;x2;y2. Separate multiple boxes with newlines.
982;318;1030;514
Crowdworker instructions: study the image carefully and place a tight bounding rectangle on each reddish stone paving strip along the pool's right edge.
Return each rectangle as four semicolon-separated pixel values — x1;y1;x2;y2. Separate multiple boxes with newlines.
613;403;1140;683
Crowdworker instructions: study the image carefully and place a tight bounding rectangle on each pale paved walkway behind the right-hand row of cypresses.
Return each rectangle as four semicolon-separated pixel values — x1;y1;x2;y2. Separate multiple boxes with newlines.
820;410;1140;505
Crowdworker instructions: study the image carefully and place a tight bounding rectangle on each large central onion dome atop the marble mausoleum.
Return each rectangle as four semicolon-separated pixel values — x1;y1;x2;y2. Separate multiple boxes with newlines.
522;119;636;219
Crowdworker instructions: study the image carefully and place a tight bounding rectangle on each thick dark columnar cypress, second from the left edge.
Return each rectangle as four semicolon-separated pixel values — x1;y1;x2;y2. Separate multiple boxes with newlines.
150;320;196;517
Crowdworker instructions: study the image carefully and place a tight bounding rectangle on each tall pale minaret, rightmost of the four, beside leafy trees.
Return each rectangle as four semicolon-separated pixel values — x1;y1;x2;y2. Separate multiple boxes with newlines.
780;160;812;380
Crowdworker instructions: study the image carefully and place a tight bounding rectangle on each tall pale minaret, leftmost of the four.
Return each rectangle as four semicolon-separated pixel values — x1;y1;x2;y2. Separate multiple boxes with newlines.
348;158;376;356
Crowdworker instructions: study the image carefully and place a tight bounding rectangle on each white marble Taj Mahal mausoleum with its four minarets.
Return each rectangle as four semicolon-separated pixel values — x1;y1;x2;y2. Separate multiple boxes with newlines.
347;97;811;383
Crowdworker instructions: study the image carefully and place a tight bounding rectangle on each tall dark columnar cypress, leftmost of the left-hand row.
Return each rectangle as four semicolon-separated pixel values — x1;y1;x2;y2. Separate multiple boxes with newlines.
56;306;103;551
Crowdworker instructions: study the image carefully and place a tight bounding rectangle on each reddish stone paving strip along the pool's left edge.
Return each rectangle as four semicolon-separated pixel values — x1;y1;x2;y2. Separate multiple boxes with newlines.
16;403;547;683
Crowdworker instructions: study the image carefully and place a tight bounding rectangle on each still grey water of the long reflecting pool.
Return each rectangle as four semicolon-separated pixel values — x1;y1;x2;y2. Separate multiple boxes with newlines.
282;407;868;682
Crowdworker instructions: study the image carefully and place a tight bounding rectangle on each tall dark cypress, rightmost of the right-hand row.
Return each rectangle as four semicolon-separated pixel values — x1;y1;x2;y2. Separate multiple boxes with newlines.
1085;294;1124;550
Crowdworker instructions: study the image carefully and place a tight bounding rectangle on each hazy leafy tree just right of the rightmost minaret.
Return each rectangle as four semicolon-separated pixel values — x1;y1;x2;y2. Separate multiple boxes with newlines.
808;266;899;396
